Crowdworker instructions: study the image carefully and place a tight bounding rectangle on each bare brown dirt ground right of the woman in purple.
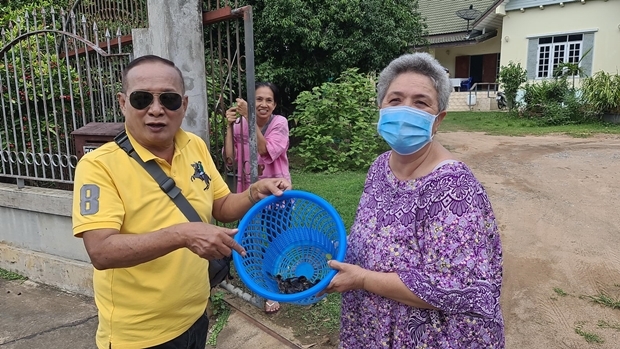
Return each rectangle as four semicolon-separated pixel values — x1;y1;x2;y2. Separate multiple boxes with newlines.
234;132;620;349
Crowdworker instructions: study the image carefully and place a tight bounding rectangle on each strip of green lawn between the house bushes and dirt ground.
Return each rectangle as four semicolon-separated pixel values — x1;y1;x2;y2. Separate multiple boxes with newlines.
439;112;620;137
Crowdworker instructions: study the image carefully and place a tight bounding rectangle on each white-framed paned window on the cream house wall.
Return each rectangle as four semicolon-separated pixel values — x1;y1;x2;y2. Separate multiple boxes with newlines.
536;34;583;79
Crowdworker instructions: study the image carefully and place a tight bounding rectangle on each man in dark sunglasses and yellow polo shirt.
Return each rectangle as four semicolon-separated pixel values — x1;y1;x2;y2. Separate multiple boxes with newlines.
73;55;290;349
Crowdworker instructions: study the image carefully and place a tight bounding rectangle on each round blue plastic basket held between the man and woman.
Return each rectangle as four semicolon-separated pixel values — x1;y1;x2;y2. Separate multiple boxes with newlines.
233;190;347;305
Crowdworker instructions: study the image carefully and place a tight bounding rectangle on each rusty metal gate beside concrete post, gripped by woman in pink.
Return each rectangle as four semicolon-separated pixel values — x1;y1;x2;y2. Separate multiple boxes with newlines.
203;0;258;191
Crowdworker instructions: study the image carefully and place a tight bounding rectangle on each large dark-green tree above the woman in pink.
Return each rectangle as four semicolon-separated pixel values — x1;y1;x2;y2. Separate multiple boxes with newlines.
241;0;426;112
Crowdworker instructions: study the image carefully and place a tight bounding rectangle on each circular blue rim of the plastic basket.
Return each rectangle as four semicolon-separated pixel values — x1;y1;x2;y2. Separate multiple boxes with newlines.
233;190;347;303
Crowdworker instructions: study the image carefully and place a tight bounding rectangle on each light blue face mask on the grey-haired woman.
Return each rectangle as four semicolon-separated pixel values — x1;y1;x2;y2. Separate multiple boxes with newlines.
377;106;437;155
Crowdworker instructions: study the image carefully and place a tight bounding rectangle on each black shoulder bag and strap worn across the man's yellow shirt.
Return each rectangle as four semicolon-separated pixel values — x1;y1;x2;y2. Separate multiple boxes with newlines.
114;130;232;287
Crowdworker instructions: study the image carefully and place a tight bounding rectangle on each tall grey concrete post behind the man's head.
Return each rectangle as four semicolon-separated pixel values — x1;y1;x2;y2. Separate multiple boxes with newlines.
133;0;209;144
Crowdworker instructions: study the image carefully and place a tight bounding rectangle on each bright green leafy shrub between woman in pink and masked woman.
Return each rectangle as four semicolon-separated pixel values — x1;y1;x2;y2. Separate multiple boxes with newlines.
291;69;379;173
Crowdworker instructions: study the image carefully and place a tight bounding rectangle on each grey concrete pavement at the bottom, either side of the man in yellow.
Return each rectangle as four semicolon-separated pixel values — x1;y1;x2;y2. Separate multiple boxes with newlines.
0;279;301;349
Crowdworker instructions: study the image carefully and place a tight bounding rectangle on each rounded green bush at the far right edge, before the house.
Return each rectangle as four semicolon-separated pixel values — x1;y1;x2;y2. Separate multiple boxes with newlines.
581;71;620;123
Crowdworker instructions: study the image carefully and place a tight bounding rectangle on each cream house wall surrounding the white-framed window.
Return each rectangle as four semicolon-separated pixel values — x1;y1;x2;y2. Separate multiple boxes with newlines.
500;0;620;77
